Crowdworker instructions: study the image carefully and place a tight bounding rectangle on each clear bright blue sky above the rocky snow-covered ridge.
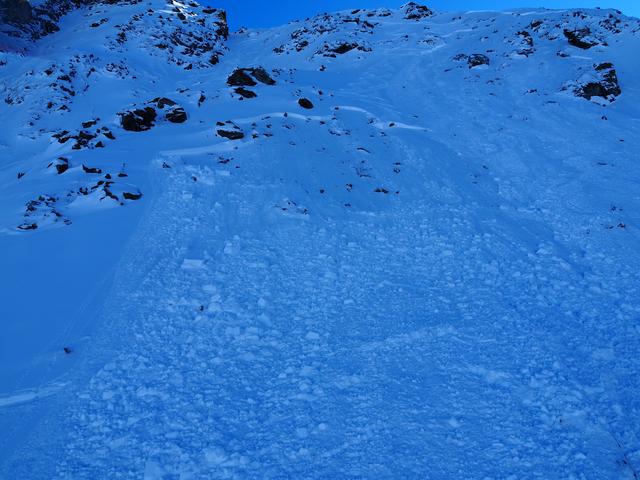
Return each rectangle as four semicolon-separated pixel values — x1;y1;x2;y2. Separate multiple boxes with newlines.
214;0;640;30
